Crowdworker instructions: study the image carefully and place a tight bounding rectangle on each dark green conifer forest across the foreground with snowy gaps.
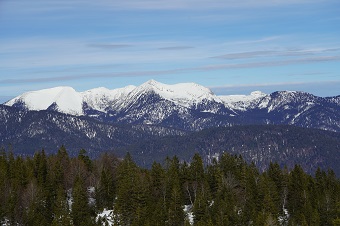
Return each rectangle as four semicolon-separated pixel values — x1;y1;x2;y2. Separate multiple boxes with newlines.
0;146;340;226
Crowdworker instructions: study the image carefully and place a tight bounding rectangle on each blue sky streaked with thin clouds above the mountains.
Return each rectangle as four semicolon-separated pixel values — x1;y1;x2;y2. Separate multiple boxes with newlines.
0;0;340;103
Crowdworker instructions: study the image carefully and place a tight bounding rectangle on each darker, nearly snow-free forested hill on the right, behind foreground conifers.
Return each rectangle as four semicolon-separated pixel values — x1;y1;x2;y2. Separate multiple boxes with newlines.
122;125;340;175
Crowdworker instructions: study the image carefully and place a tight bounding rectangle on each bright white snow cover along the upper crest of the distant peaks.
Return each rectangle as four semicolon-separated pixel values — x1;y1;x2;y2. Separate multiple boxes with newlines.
5;80;256;115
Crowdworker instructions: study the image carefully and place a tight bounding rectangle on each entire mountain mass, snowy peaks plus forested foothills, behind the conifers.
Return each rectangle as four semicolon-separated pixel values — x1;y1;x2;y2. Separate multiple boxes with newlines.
0;80;340;175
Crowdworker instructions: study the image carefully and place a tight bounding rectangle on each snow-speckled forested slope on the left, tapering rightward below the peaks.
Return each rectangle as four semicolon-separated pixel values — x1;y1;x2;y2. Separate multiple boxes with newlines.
0;105;184;157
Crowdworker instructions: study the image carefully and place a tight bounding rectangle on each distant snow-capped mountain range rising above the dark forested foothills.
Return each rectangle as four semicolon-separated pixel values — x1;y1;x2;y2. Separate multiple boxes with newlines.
4;80;340;132
